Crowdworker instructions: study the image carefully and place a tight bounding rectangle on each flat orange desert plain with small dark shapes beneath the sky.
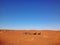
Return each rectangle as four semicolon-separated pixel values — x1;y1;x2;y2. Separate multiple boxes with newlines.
0;29;60;45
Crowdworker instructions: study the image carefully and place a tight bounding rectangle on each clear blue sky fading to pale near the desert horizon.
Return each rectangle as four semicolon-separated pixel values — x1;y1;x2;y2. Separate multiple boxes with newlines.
0;0;60;29
